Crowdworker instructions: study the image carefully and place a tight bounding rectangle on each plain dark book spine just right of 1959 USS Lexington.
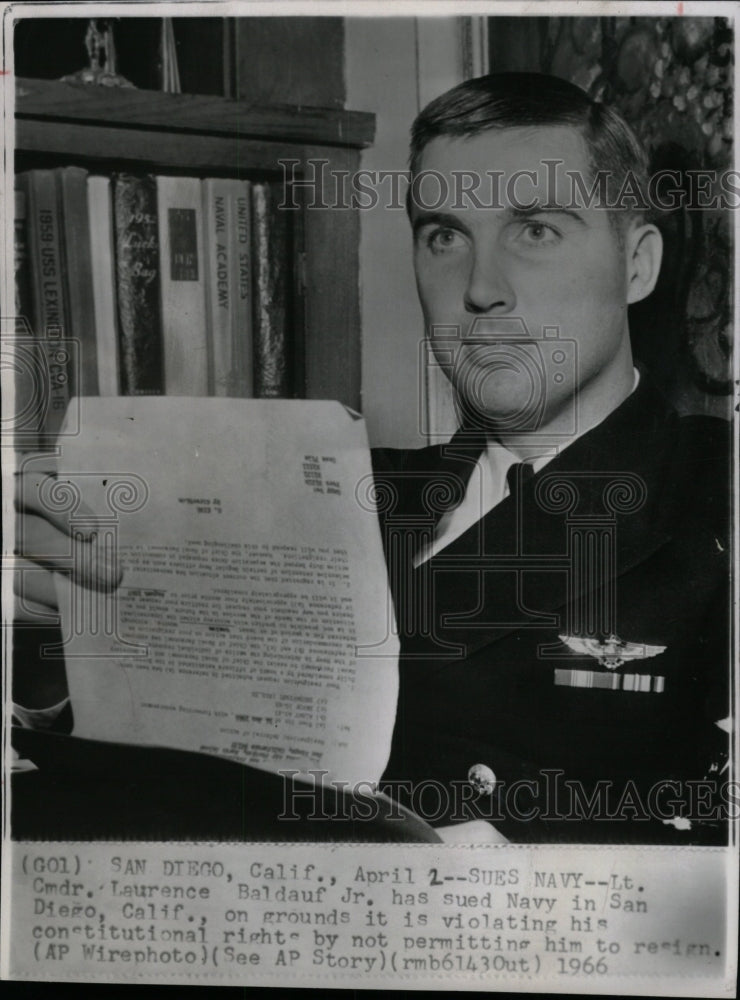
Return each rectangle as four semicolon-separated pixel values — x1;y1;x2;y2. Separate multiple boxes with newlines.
56;167;98;396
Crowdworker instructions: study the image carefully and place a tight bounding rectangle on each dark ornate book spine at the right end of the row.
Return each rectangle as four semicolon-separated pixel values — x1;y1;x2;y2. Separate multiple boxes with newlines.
252;182;289;399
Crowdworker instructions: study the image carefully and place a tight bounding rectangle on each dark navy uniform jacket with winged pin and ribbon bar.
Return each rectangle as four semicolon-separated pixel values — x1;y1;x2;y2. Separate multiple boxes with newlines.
374;374;737;843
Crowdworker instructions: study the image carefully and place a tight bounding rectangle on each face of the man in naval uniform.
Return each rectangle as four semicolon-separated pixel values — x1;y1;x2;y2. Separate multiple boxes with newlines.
411;126;631;432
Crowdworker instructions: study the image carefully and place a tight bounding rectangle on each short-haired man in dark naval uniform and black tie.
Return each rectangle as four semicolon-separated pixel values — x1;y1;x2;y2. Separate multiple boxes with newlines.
14;74;731;843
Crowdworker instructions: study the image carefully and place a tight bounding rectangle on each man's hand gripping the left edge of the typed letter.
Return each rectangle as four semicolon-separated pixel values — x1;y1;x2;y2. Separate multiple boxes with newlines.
13;455;121;625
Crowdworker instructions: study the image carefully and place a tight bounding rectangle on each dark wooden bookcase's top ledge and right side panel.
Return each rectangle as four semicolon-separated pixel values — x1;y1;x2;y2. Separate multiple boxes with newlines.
15;78;375;409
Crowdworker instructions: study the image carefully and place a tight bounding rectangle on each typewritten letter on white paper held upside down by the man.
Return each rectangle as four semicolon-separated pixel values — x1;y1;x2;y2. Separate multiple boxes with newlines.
57;397;398;782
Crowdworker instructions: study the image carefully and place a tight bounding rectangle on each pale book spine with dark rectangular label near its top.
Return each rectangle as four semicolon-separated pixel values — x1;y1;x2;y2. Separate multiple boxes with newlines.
156;177;208;396
